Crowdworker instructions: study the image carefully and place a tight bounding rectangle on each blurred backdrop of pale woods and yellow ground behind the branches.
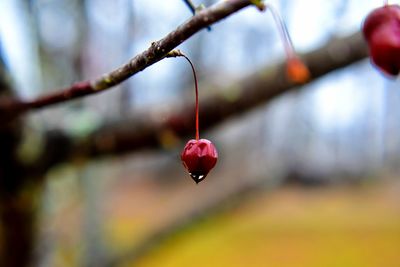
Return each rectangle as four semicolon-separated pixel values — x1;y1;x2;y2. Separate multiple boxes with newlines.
0;0;400;267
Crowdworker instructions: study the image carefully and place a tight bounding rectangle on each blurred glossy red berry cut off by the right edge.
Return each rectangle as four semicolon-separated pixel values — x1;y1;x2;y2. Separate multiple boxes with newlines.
362;4;400;76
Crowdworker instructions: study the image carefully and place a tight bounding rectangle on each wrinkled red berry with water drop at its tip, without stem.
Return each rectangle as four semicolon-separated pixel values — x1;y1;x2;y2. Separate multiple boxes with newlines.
181;139;218;183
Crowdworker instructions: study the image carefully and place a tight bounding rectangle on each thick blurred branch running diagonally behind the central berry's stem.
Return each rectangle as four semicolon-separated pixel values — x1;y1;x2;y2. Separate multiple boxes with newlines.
36;33;367;174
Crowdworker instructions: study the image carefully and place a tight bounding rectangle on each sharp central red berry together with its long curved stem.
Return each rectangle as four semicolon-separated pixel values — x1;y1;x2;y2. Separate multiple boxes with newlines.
167;50;218;184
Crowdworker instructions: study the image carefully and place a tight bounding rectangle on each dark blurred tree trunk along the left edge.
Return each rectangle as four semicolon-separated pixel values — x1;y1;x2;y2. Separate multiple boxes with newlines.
0;54;36;267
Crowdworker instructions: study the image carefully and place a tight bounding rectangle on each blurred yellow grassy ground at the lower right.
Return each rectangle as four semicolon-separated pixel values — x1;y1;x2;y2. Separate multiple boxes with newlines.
123;185;400;267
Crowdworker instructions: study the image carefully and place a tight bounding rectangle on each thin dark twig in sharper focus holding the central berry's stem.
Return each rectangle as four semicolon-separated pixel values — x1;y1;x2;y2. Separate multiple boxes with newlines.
0;0;260;119
